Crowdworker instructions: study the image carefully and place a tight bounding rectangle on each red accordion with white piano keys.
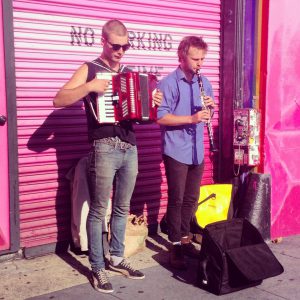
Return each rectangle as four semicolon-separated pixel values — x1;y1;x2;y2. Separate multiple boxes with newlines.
91;72;157;124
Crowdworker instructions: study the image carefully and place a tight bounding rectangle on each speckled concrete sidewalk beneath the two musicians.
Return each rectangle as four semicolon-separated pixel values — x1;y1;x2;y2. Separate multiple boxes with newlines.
0;234;300;300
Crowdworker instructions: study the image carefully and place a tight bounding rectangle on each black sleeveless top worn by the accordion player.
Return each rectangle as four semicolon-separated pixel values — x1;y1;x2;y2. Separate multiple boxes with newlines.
83;58;136;145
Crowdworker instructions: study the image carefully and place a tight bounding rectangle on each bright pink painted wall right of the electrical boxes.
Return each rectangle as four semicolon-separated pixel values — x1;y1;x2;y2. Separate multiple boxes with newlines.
264;0;300;238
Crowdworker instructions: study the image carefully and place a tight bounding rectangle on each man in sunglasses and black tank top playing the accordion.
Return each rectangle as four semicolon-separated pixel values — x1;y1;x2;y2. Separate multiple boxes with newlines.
53;20;162;293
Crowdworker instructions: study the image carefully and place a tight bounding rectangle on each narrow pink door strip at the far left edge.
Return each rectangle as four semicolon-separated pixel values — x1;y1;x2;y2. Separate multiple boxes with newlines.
0;0;10;250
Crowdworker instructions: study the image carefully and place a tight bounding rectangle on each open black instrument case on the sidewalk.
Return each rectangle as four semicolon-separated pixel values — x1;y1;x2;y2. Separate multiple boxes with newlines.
197;218;283;295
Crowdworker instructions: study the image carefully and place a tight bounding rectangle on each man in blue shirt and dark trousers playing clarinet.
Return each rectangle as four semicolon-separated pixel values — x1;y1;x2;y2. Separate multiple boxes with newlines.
157;36;215;269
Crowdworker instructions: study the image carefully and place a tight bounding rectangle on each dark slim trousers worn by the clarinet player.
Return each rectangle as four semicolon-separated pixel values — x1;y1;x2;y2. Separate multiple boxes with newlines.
163;155;204;242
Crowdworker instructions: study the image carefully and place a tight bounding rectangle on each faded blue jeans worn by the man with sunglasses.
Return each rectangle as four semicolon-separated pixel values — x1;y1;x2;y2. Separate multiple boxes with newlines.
87;140;138;271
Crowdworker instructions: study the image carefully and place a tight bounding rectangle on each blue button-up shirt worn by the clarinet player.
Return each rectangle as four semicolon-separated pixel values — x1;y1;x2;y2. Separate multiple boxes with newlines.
157;67;213;165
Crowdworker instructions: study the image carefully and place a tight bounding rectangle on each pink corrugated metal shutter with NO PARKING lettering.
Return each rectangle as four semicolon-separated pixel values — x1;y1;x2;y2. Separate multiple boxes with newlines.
13;0;220;247
